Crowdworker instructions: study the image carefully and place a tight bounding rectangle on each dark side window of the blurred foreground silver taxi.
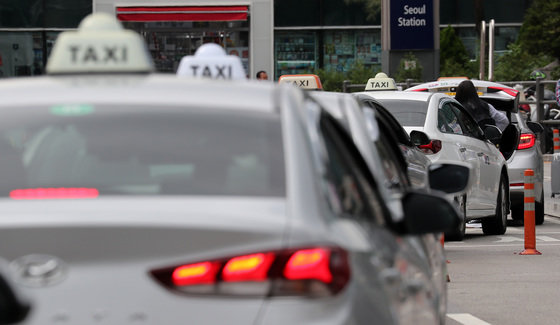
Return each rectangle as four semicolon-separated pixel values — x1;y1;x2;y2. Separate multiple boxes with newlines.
319;114;385;225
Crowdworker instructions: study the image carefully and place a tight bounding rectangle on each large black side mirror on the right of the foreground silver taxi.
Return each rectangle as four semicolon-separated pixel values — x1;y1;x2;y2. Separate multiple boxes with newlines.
400;191;459;235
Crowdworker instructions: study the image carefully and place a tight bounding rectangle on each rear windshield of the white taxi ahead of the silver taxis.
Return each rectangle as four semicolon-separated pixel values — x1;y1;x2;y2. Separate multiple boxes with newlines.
378;99;427;126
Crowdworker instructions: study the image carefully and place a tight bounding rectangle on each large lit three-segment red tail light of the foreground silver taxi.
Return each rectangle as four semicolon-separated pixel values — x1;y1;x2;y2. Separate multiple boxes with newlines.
150;247;350;297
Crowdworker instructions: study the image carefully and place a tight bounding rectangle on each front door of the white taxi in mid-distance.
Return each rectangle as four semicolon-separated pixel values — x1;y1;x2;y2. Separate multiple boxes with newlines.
450;102;501;210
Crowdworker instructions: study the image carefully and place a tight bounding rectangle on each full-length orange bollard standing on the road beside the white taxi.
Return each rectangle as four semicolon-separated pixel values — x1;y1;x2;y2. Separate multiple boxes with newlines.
519;169;541;255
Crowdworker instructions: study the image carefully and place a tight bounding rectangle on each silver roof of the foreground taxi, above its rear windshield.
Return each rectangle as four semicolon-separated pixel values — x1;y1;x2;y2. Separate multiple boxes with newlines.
0;74;282;113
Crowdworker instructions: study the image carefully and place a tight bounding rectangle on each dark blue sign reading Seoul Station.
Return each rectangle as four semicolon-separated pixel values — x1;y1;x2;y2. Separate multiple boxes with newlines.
390;0;434;50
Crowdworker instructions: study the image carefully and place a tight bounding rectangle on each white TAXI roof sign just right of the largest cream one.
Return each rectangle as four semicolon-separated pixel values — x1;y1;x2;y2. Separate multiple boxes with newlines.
177;43;247;80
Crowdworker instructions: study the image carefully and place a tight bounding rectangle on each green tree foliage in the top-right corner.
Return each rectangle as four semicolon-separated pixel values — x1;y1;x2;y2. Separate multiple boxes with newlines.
519;0;560;59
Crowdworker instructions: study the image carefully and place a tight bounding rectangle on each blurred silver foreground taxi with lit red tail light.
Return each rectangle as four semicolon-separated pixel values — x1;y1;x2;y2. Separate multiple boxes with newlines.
0;13;457;324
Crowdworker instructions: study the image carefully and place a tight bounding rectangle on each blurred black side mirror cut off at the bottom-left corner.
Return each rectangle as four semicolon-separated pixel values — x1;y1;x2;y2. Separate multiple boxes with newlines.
0;261;30;325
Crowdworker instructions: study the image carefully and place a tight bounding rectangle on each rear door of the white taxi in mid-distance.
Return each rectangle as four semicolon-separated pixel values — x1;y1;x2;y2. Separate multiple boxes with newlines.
437;99;484;209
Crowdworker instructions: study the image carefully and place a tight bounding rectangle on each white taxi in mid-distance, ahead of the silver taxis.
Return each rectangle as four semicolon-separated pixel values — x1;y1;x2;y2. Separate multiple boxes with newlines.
357;73;516;240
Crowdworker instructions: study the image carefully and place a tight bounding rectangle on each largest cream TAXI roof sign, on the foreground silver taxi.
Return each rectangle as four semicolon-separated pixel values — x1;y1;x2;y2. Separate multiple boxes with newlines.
46;12;154;74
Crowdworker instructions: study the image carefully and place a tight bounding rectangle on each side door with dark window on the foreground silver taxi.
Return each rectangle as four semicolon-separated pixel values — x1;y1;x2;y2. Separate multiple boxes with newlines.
320;110;438;324
